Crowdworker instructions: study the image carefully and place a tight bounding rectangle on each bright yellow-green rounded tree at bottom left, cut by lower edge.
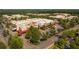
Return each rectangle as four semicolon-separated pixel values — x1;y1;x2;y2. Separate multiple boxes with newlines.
8;36;23;49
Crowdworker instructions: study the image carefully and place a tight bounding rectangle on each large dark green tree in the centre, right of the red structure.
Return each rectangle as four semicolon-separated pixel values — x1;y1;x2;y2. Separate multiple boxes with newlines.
25;26;40;44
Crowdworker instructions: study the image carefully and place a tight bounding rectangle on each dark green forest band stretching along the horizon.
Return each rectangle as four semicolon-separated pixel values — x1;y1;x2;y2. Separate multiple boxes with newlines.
0;9;79;14
